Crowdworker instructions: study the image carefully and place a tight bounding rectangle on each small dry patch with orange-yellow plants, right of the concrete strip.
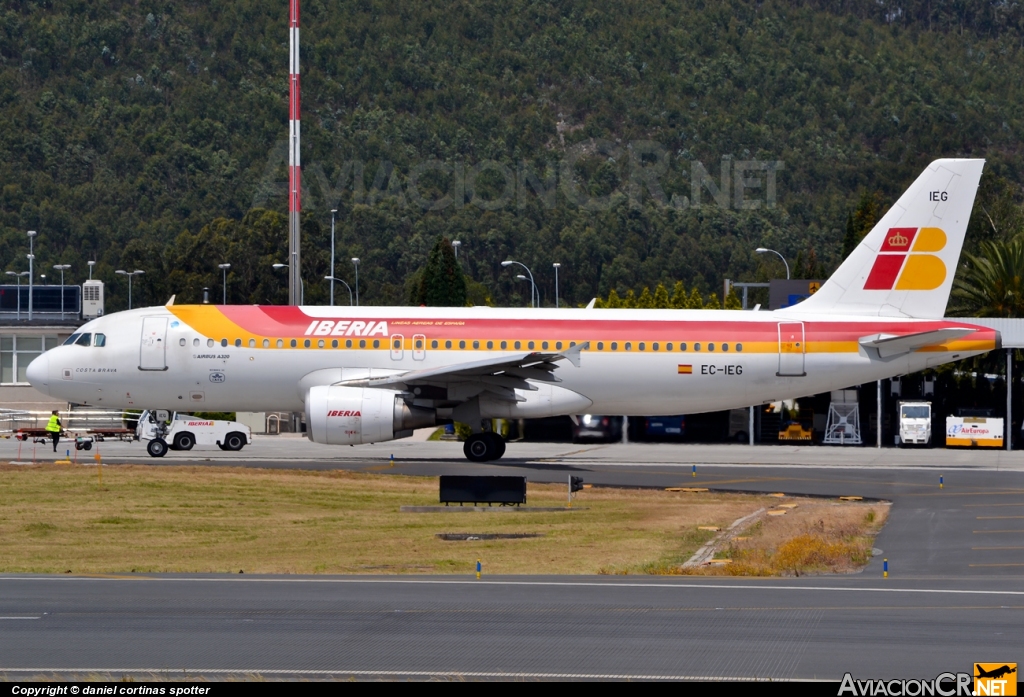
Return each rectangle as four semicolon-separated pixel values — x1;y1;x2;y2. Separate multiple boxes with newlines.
687;499;889;576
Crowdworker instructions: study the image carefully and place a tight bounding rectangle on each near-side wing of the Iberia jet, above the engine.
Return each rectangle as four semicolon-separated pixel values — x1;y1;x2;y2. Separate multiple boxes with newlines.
337;342;590;394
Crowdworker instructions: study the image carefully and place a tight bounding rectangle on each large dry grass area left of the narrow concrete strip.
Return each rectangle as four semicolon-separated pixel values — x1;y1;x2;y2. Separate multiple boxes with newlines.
0;465;774;574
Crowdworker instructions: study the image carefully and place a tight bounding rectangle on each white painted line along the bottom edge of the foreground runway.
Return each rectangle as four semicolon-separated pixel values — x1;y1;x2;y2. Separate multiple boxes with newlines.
0;667;823;683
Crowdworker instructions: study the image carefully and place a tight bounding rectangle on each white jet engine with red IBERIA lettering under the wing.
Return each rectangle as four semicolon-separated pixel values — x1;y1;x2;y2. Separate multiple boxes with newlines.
306;385;436;445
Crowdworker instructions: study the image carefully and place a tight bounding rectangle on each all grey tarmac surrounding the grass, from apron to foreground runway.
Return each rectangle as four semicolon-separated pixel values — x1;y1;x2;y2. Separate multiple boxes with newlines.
0;439;1024;680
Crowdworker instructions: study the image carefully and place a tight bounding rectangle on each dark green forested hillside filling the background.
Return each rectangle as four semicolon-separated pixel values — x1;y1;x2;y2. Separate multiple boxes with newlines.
0;0;1024;310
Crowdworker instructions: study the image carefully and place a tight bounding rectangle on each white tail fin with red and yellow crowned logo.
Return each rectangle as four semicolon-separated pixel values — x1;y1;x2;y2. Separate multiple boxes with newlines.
788;160;985;318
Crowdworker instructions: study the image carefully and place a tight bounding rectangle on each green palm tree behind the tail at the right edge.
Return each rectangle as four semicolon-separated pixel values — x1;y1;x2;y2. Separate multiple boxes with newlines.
952;236;1024;317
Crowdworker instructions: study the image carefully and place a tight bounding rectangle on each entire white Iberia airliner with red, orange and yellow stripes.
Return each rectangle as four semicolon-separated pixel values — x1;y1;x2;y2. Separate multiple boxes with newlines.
28;159;1000;462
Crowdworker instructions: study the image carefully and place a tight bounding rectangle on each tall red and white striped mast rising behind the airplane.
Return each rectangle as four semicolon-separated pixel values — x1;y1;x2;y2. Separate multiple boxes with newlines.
288;0;302;305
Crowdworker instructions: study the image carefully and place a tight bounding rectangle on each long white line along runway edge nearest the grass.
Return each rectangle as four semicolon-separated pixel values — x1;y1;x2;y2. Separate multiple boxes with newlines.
0;575;1024;596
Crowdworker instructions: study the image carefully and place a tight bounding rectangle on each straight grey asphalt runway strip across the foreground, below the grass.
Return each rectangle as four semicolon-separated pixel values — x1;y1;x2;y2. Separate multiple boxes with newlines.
0;576;1024;680
